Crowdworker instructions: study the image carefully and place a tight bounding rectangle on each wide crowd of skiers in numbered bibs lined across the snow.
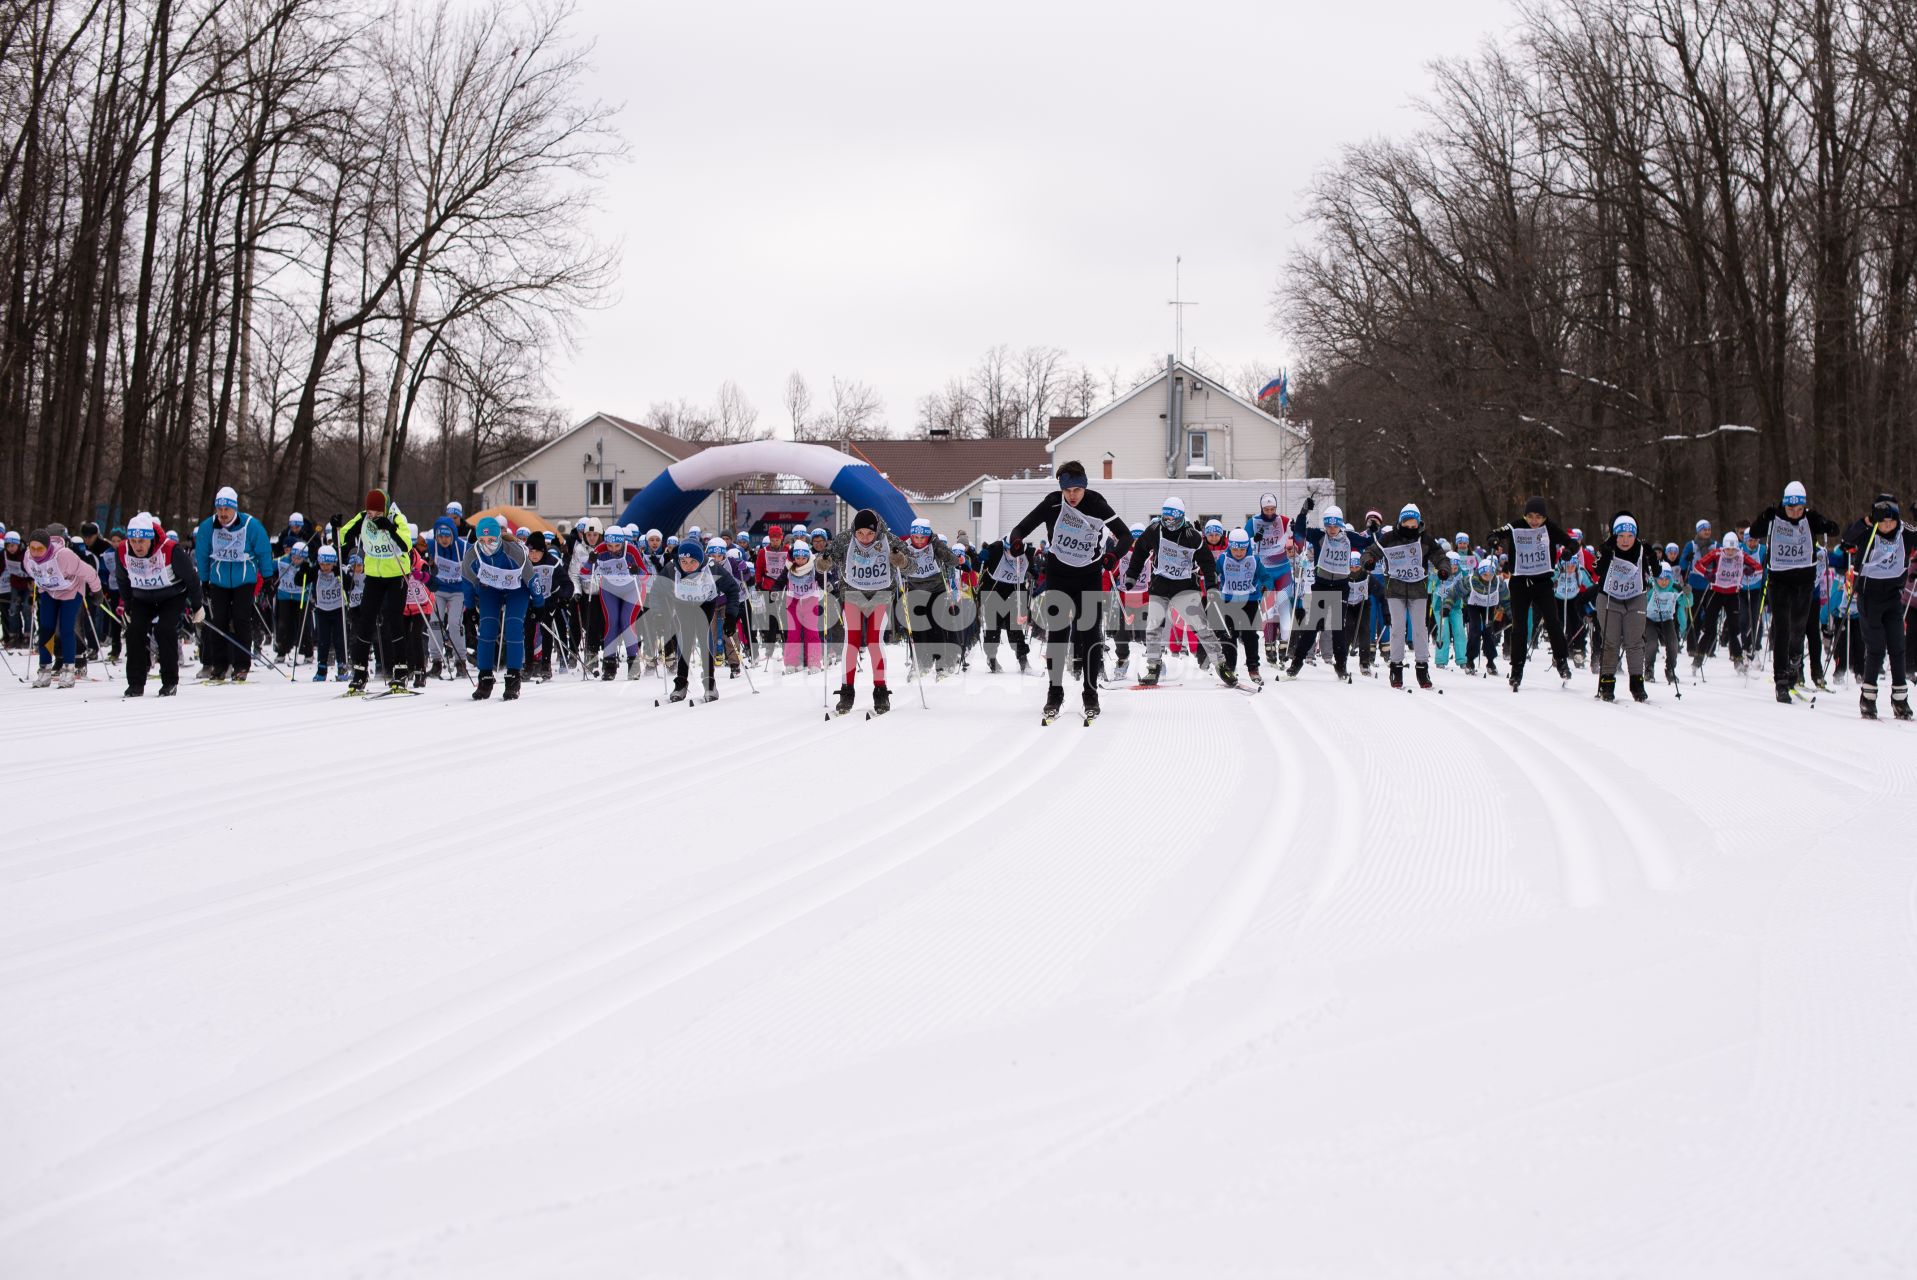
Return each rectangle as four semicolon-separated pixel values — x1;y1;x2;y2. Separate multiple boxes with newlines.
0;462;1917;722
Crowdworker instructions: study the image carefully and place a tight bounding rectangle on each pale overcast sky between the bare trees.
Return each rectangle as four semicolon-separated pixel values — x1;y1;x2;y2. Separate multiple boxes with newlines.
552;0;1511;433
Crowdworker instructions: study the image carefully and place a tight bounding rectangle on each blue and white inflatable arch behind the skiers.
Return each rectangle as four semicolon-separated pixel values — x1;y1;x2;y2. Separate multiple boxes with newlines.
619;441;912;538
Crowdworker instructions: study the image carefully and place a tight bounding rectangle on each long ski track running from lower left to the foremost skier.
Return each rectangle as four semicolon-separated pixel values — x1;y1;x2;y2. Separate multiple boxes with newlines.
0;701;1058;1238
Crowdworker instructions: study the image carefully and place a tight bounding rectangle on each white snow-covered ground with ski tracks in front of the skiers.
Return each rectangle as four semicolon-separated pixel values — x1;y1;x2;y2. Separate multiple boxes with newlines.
0;659;1917;1280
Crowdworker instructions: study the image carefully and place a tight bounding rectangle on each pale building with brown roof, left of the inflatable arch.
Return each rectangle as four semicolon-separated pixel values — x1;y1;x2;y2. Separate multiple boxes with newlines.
475;414;721;529
